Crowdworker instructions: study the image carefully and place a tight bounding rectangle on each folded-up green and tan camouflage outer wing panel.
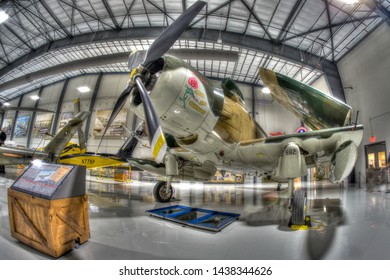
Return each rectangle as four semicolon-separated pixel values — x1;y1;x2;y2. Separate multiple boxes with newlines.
260;68;352;130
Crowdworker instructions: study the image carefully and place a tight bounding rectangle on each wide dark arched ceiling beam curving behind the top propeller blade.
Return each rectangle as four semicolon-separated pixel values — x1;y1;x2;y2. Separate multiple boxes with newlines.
0;27;331;77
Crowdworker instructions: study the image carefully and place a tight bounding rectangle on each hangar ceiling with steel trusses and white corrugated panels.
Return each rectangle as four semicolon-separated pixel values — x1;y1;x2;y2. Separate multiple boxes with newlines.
0;0;390;102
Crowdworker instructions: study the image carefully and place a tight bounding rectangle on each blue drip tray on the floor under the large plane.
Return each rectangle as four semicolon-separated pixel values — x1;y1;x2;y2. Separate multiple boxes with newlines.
146;205;240;231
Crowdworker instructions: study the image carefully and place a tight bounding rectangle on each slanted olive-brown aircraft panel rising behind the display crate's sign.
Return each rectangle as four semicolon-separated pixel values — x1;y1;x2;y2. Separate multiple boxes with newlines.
43;112;90;158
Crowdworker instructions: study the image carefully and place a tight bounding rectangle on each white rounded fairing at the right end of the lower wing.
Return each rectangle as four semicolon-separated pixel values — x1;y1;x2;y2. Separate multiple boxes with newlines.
329;141;358;183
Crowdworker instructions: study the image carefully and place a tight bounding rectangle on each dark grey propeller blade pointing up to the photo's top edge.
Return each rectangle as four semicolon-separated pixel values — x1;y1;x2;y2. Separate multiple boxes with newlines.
142;1;207;67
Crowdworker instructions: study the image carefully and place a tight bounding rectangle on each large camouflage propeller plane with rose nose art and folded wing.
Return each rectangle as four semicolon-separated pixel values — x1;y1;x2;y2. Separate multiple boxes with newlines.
100;1;363;225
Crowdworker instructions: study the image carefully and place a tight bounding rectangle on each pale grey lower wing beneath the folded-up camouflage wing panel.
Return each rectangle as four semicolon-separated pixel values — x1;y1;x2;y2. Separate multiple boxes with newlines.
238;125;363;183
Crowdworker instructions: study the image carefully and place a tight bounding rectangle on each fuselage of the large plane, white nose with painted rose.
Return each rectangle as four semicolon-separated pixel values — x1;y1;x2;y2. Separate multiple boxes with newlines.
131;56;276;173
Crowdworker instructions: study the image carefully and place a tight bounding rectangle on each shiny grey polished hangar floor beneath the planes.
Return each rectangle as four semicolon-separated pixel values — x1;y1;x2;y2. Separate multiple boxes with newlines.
0;171;390;260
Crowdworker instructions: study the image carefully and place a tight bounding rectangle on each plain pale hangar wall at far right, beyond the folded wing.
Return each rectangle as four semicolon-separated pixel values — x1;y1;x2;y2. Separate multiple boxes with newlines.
337;23;390;178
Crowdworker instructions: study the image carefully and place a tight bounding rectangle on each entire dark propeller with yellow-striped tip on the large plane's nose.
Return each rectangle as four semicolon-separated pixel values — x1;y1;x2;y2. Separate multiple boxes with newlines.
99;1;206;163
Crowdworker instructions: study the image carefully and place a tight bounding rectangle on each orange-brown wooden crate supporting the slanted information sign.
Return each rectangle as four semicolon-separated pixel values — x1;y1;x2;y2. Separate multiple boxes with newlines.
8;189;90;258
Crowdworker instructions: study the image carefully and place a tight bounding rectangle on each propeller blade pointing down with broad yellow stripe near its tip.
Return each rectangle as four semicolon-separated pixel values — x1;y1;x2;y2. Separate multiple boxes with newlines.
135;76;167;163
